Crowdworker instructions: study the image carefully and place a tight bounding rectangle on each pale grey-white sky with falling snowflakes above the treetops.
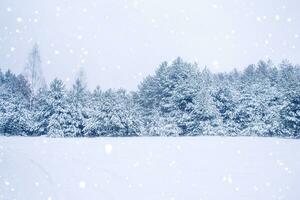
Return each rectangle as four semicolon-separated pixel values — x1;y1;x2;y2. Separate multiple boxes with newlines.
0;0;300;90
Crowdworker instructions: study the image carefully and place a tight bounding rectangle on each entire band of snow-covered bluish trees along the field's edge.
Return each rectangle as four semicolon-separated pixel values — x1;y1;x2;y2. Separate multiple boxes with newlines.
0;46;300;138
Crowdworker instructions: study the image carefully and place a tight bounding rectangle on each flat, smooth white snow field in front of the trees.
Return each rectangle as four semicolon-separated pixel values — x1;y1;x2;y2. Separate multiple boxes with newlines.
0;137;300;200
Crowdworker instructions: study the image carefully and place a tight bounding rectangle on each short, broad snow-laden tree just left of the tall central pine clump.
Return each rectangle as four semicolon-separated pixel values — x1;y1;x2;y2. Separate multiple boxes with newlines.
84;90;140;136
